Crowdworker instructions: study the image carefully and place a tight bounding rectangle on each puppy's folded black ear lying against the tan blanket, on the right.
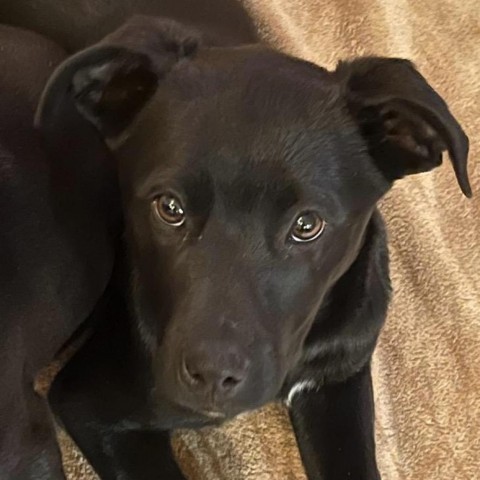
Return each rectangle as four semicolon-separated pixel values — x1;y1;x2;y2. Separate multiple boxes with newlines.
335;57;472;197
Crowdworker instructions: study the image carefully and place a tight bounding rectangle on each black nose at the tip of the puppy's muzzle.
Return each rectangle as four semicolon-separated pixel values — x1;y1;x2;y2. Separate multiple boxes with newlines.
182;347;249;404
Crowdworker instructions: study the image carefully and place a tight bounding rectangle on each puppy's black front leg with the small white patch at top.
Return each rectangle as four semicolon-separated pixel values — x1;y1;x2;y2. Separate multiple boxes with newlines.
290;365;380;480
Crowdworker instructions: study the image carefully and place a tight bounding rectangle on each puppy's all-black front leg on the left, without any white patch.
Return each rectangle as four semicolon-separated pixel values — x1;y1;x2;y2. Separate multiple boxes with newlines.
47;290;185;480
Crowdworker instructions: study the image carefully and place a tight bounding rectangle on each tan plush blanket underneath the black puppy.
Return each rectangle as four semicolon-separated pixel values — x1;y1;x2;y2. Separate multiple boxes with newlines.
58;0;480;480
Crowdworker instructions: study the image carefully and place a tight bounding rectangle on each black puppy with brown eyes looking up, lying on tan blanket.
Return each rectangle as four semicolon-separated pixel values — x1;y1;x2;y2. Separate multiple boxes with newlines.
0;2;471;480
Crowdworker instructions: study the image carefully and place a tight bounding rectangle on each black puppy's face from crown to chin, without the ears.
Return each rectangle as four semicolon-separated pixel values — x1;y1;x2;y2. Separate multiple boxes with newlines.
116;48;387;413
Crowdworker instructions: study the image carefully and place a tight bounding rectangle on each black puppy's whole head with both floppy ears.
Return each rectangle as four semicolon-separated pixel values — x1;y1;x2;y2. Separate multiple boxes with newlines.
37;17;471;416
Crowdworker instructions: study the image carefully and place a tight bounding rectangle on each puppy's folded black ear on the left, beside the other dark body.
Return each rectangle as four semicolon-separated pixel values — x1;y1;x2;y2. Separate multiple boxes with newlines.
35;16;199;139
